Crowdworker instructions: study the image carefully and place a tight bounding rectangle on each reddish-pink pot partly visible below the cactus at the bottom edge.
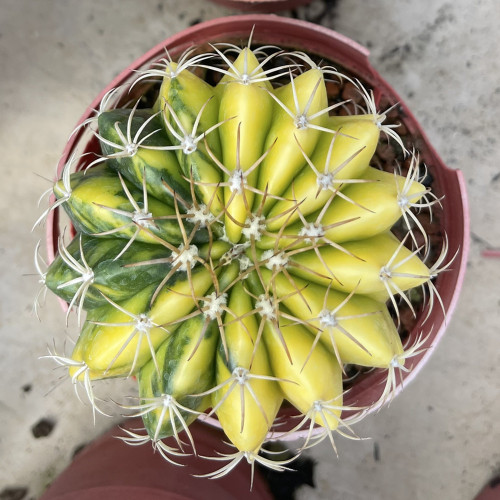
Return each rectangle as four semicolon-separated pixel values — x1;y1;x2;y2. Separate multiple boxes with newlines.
40;419;273;500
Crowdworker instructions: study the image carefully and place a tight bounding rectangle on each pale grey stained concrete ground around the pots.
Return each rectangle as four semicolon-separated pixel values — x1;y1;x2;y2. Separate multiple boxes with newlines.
0;0;500;500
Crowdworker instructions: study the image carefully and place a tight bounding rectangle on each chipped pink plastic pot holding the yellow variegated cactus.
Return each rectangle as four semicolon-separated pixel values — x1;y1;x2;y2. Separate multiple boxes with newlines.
47;15;469;439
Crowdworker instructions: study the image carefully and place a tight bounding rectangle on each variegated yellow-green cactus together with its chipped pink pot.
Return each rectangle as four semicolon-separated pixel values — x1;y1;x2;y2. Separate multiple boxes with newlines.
36;16;467;484
